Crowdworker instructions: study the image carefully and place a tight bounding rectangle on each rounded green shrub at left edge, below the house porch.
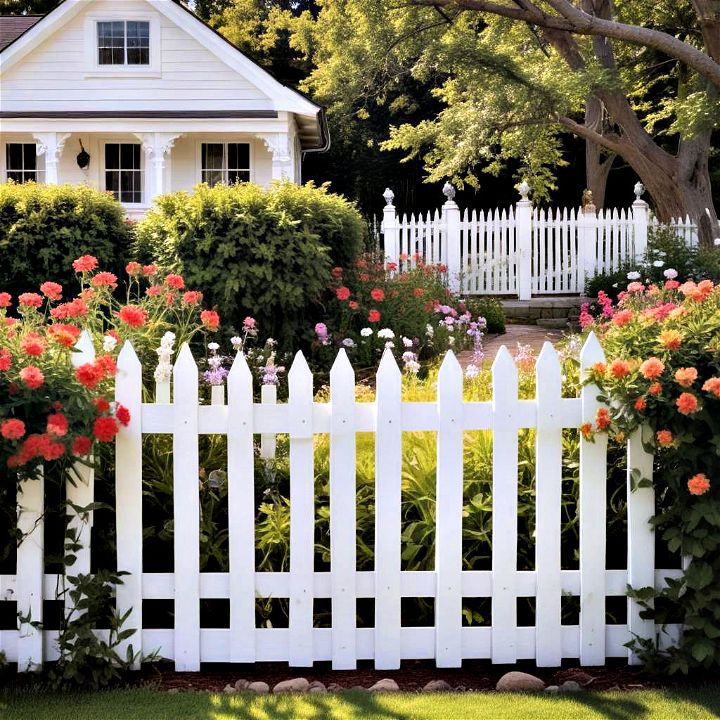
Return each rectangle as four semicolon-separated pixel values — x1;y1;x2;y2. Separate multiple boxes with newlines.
0;182;132;293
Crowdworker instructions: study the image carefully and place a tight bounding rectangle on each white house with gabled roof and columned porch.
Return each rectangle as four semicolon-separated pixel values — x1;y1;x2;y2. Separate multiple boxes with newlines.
0;0;329;217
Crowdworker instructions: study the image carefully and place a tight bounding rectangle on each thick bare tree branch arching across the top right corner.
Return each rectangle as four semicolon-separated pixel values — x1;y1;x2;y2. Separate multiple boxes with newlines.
407;0;720;88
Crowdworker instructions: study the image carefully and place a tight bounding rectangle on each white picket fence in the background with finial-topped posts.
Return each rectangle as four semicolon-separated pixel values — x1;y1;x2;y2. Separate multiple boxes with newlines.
381;186;697;300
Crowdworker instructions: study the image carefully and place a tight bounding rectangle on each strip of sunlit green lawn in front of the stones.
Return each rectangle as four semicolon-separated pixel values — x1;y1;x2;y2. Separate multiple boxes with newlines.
0;685;720;720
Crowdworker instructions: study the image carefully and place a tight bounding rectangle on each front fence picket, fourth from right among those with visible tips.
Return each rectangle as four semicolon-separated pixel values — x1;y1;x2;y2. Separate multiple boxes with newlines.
435;350;463;667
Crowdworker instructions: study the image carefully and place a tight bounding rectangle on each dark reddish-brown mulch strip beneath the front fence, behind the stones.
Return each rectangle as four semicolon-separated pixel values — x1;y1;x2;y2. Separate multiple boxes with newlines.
138;661;703;692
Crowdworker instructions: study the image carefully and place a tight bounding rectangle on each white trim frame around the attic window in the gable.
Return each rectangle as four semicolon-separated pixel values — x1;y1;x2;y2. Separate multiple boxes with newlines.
83;10;162;78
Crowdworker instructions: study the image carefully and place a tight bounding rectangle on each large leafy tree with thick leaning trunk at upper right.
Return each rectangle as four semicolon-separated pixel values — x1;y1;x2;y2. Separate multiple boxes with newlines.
306;0;720;243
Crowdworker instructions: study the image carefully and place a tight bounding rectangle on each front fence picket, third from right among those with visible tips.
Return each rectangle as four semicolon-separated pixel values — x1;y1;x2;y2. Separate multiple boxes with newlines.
491;345;518;664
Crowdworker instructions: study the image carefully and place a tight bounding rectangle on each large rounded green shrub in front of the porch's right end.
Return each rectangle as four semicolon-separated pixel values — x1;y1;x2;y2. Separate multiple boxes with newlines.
137;183;365;345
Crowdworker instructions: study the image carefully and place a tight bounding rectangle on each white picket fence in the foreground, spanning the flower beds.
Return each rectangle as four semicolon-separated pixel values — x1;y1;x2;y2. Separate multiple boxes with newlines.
0;335;680;671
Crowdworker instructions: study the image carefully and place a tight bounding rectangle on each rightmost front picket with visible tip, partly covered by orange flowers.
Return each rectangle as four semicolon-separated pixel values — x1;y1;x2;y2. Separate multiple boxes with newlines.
579;332;607;665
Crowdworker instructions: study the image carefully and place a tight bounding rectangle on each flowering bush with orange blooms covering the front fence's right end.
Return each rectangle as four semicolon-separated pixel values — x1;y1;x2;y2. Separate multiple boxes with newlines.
581;268;720;672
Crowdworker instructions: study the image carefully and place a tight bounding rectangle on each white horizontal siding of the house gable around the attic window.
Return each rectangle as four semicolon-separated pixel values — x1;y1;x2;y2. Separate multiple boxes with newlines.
0;0;273;111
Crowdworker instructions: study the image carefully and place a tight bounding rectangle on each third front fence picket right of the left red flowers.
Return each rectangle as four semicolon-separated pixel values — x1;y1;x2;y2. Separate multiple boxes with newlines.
229;352;256;662
